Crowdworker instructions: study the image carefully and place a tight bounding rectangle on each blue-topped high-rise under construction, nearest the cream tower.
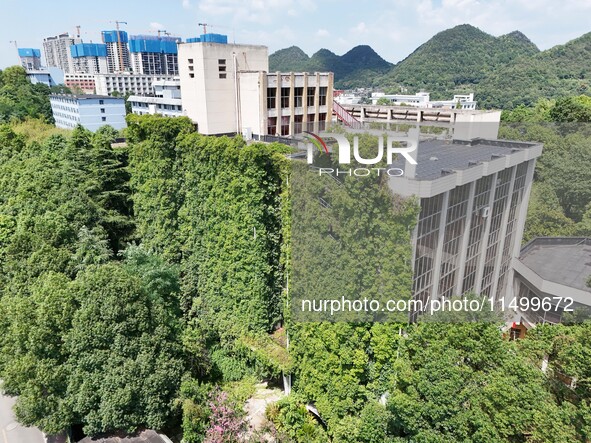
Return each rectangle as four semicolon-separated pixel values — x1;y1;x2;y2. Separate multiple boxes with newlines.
129;35;181;75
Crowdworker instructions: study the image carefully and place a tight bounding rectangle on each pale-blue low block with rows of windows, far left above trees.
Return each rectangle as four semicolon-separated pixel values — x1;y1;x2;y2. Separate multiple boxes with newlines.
49;94;127;132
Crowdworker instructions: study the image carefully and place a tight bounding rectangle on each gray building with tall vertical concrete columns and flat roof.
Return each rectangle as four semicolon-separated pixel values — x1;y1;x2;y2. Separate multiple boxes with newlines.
389;138;542;314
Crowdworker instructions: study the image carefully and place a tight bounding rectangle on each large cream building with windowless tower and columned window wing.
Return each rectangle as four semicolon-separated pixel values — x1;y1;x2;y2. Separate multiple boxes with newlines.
178;34;333;138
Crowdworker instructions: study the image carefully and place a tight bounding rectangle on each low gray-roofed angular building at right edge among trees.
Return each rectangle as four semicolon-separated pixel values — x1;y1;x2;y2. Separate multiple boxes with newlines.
508;237;591;326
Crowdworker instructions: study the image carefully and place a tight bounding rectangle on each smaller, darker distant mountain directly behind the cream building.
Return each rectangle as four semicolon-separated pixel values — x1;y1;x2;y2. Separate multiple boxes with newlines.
269;45;393;88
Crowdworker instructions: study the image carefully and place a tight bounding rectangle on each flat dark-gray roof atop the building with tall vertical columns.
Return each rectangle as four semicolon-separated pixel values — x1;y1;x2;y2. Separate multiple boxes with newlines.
392;138;537;180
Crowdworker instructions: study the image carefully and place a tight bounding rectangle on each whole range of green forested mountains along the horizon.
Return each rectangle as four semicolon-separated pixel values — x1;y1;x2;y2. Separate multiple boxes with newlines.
269;25;591;109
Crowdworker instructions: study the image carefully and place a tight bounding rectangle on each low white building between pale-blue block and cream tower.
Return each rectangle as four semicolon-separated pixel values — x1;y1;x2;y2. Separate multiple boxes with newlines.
127;80;183;117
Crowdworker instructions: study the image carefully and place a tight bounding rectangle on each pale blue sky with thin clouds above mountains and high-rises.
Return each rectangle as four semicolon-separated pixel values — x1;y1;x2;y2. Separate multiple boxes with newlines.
0;0;591;69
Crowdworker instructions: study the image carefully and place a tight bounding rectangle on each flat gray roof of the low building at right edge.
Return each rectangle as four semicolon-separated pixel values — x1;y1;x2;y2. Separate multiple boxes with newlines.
519;237;591;292
